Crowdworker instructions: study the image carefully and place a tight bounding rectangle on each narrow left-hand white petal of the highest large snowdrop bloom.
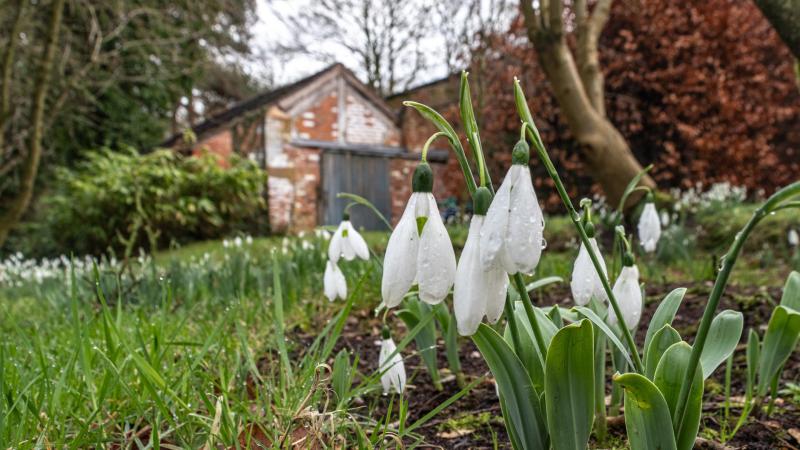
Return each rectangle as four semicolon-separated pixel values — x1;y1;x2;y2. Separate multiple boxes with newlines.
480;166;514;269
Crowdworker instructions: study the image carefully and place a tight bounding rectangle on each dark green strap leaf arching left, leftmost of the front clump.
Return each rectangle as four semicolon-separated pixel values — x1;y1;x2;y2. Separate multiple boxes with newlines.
472;324;549;450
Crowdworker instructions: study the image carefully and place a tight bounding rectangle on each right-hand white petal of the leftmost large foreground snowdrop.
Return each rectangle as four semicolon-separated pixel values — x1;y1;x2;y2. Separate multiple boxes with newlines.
416;193;456;305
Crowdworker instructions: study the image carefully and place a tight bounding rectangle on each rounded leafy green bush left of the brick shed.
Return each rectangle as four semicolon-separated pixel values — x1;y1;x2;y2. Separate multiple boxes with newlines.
12;149;267;256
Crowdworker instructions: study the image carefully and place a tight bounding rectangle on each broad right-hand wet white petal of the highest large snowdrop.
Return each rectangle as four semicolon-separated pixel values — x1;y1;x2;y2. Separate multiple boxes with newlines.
506;164;544;273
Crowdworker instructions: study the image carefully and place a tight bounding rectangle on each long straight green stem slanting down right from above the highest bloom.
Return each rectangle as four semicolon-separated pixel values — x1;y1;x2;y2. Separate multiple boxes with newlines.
514;80;648;374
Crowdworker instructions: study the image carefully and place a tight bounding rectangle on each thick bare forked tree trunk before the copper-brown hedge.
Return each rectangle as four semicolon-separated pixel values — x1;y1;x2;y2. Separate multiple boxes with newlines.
521;0;655;206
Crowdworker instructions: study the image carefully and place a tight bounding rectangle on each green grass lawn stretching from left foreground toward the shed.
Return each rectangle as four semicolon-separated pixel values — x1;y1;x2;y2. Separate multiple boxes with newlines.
0;208;789;448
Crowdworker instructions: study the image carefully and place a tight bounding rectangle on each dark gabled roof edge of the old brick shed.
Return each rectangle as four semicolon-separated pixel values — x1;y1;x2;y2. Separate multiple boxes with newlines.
161;63;396;148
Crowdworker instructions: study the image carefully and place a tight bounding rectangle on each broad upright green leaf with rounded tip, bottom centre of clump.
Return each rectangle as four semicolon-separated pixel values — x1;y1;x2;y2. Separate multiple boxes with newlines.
544;320;594;450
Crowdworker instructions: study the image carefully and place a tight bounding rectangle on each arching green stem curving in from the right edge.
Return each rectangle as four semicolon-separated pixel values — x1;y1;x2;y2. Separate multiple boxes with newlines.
672;181;800;433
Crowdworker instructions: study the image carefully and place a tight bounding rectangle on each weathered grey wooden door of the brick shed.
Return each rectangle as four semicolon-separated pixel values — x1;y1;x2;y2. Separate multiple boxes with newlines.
320;152;392;230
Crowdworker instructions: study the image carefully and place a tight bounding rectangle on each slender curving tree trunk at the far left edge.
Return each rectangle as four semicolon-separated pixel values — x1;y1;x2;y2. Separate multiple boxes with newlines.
0;0;64;246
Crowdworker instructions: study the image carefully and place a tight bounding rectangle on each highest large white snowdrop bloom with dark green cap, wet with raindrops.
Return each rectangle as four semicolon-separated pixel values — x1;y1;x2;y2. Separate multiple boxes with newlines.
480;140;544;274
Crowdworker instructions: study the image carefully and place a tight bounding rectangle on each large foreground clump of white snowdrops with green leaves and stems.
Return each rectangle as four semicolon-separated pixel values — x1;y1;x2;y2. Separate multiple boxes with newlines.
370;74;800;450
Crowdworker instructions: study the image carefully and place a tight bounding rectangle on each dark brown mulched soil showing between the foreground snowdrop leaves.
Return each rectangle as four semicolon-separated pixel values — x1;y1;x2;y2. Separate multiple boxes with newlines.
302;282;800;449
